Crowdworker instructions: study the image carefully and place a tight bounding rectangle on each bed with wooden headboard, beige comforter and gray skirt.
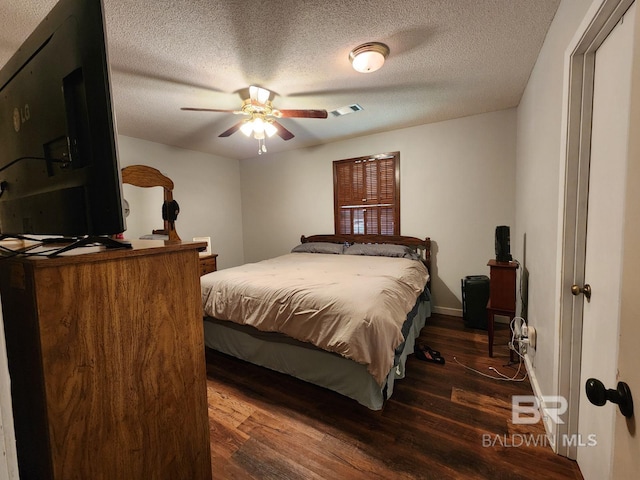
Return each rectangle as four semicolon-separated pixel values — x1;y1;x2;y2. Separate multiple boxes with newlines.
201;235;431;410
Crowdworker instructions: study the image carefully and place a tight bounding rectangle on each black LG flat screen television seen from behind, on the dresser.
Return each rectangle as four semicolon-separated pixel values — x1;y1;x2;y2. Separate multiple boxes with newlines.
0;0;125;251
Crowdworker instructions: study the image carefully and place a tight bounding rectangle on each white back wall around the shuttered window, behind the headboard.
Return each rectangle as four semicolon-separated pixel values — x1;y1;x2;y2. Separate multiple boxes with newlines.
240;109;516;314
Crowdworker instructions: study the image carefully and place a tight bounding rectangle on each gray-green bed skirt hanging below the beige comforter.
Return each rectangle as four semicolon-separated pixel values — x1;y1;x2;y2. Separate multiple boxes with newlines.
204;291;431;410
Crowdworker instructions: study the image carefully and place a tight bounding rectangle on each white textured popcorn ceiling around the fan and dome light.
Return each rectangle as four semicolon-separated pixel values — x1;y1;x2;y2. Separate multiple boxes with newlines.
0;0;559;159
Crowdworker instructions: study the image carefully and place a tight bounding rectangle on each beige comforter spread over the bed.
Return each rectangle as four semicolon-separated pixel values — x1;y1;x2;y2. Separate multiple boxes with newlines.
201;253;429;385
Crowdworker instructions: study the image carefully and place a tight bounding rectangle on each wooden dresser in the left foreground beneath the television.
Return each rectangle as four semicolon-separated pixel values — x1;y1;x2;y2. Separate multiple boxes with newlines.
0;240;211;480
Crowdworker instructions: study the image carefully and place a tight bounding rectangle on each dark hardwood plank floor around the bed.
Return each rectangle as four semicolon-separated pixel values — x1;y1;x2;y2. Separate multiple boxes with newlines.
207;315;582;480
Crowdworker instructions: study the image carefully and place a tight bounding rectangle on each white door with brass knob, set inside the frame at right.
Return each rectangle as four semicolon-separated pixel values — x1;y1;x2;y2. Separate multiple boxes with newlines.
577;4;640;480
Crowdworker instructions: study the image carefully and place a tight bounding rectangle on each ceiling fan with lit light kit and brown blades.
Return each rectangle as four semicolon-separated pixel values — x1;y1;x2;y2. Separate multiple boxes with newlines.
181;85;328;154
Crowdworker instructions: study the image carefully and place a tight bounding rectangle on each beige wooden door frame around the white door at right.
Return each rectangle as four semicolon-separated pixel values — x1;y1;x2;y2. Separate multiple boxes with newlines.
546;0;634;460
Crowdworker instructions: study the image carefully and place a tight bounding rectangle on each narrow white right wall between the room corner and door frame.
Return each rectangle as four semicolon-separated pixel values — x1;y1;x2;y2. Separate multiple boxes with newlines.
511;0;590;395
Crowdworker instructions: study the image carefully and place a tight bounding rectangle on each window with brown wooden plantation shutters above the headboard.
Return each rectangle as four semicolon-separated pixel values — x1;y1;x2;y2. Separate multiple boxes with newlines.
333;152;400;235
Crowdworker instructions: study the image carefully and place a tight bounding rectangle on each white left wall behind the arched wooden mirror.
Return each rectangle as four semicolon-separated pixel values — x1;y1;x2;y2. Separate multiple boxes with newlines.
118;136;244;268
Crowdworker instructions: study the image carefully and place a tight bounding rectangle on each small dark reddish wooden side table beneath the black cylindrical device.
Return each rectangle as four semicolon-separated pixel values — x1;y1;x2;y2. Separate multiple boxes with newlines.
487;260;518;357
